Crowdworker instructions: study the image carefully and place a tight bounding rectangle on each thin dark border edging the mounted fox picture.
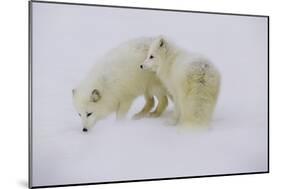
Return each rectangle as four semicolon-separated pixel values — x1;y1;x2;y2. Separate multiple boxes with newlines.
28;0;270;188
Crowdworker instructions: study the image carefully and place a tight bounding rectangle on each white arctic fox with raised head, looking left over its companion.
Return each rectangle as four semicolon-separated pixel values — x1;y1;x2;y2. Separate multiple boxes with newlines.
140;37;220;126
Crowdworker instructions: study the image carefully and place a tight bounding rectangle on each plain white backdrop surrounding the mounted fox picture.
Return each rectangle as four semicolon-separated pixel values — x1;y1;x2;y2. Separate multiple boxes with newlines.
1;1;280;188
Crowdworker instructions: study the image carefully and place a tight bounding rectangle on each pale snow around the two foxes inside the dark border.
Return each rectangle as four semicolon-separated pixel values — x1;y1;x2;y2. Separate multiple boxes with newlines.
32;3;268;186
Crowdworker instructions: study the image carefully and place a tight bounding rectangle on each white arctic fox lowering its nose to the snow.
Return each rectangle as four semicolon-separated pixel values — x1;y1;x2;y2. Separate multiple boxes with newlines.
72;38;168;131
